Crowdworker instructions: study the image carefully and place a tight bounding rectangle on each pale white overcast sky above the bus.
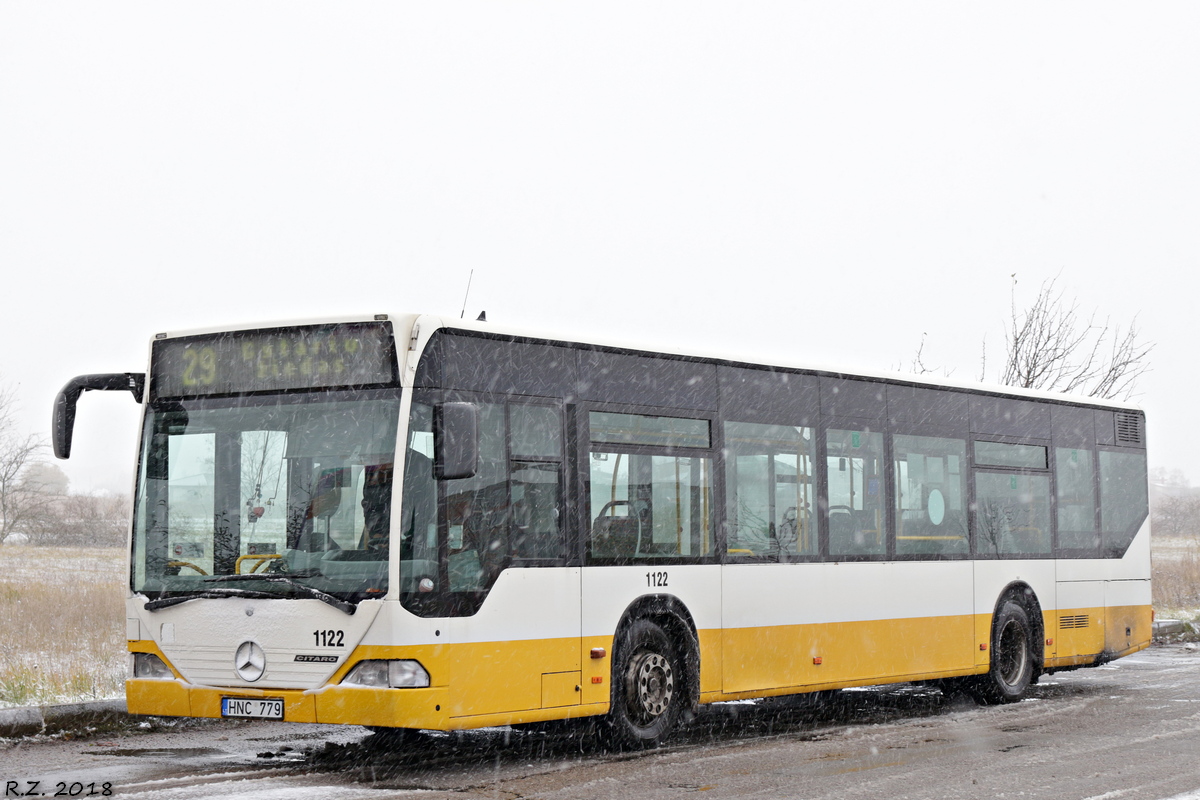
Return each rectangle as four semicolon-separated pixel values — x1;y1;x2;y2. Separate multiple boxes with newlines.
0;0;1200;492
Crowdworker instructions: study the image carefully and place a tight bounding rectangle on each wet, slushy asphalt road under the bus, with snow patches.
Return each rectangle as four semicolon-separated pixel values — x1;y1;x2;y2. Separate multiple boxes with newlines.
7;645;1200;800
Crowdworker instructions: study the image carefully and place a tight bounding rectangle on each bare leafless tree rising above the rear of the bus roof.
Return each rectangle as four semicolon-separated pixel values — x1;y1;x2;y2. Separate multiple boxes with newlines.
1000;273;1154;399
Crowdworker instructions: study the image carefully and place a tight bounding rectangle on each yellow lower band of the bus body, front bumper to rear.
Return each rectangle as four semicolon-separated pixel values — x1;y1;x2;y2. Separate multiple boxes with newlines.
126;606;1151;730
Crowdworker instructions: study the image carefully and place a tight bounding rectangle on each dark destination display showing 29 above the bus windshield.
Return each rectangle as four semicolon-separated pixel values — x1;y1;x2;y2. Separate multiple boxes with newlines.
151;323;396;397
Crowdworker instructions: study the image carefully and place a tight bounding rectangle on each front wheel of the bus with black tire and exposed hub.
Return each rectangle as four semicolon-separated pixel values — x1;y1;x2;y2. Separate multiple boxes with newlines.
605;619;688;750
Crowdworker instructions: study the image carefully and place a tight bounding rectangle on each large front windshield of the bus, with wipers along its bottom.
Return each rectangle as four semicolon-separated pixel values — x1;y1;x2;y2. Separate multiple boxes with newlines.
132;390;400;609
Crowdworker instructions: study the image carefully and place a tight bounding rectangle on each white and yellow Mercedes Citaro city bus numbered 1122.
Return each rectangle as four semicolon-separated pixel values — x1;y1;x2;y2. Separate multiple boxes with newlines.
54;315;1151;747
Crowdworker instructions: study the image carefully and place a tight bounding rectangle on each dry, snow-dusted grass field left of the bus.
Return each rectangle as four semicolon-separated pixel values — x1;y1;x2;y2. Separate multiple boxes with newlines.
0;545;126;708
